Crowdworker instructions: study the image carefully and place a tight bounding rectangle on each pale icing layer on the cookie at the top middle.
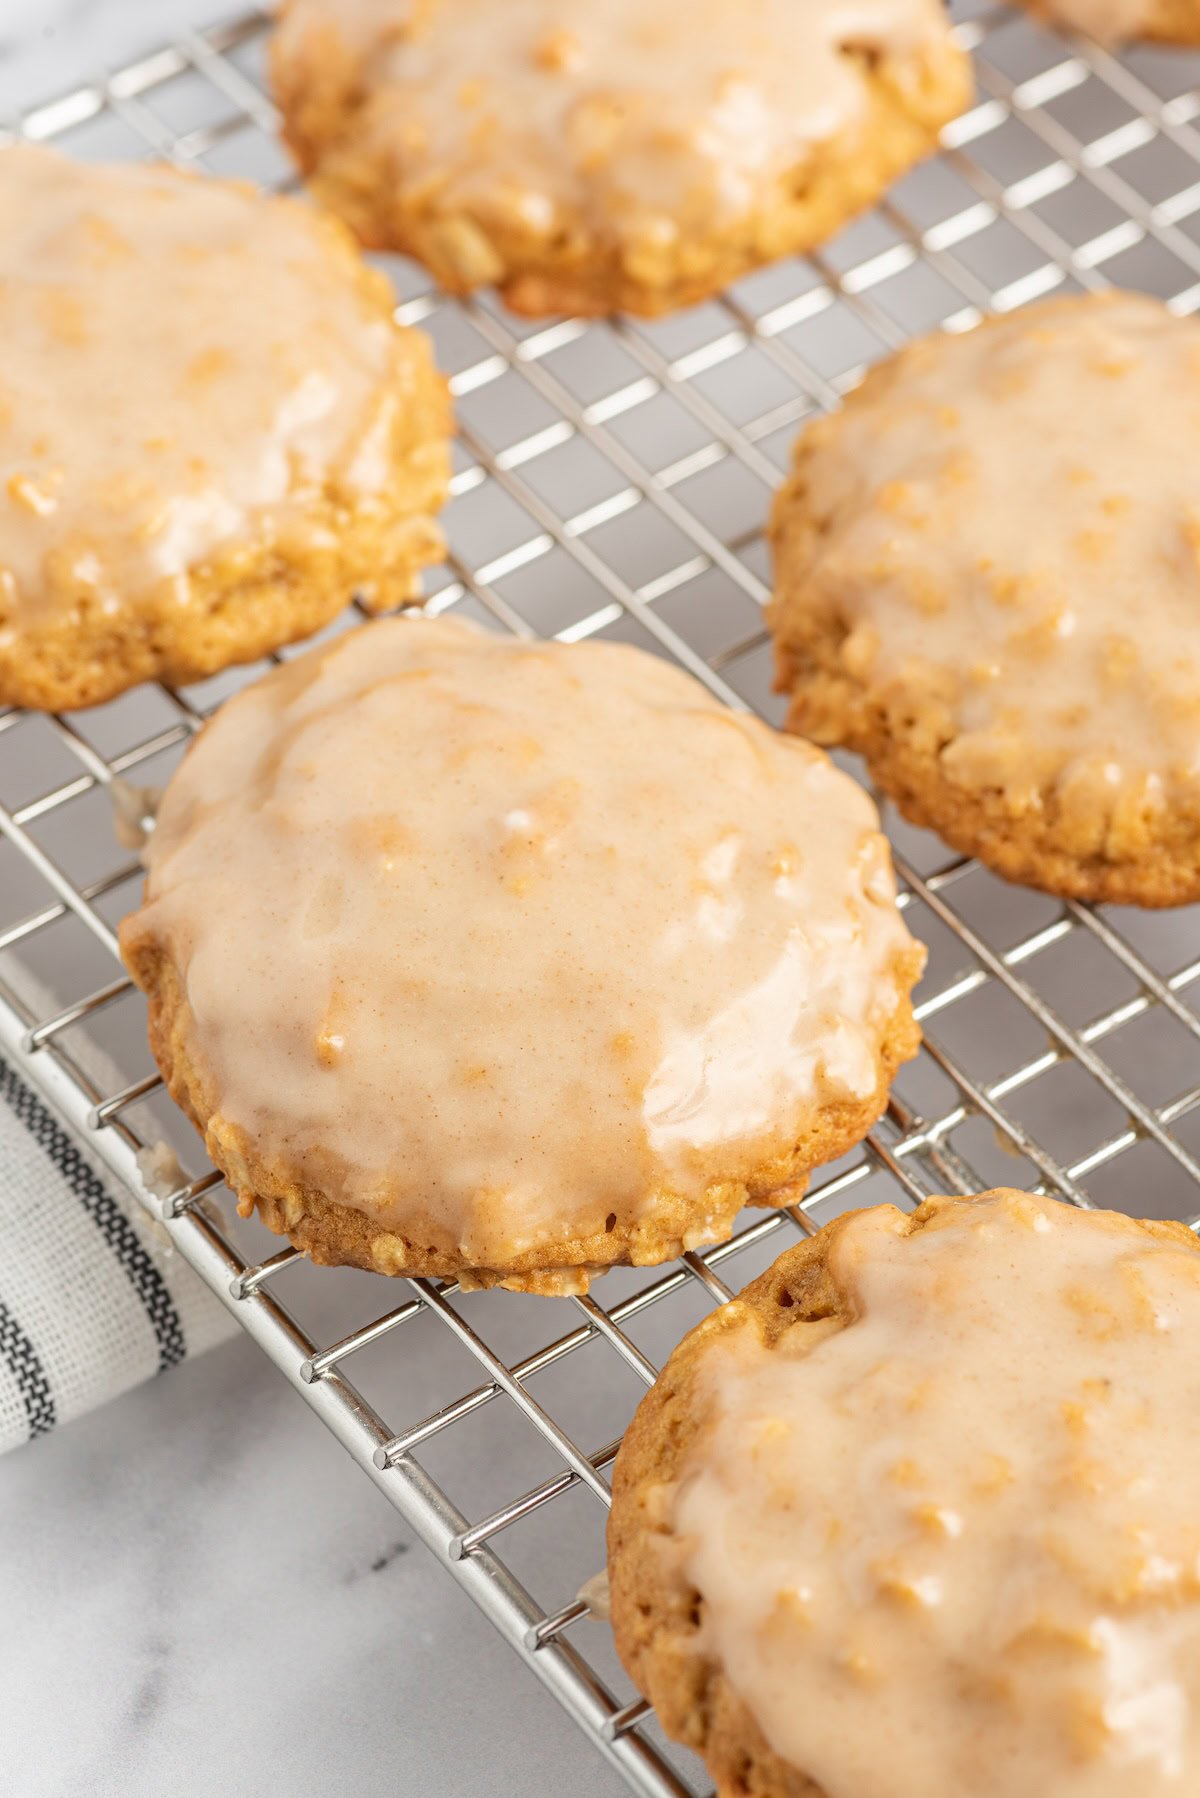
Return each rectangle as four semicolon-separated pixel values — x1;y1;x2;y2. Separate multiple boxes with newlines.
275;0;946;250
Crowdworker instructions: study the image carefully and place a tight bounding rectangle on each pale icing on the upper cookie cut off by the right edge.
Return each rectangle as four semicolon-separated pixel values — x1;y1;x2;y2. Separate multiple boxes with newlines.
783;295;1200;847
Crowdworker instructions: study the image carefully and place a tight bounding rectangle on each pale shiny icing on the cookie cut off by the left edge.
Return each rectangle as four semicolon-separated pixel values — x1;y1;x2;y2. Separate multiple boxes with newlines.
0;144;396;631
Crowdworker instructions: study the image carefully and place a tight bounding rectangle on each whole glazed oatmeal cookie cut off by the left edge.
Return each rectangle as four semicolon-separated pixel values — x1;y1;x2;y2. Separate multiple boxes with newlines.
0;144;450;710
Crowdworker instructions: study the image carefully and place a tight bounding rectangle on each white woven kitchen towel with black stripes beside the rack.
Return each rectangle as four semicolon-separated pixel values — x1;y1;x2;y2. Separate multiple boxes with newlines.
0;1059;236;1453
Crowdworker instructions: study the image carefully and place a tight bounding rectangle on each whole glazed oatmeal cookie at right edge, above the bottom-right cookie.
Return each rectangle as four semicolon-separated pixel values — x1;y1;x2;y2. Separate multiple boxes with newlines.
770;293;1200;906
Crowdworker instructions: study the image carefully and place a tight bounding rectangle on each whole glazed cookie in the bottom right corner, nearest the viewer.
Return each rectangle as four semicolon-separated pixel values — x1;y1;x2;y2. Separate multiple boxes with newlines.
608;1192;1200;1798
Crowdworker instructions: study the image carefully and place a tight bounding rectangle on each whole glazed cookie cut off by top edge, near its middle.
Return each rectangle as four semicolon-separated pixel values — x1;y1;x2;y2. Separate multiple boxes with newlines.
272;0;970;315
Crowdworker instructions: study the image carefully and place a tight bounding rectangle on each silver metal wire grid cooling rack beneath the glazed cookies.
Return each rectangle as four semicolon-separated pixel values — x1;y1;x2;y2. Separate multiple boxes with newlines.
0;7;1200;1794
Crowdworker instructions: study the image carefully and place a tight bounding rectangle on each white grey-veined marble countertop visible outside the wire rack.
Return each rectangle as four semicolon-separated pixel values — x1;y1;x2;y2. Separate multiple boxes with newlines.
0;0;624;1798
